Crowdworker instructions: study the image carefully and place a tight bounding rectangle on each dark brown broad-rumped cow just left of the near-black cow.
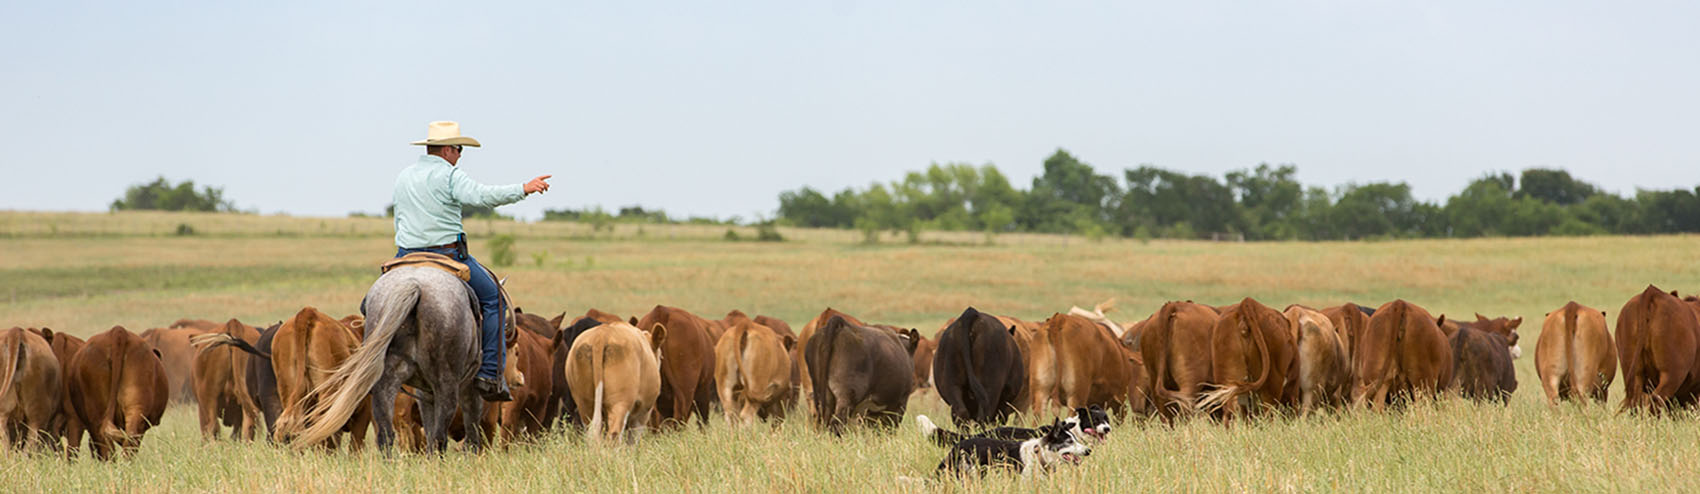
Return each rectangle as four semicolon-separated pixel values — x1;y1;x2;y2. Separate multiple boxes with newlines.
804;316;920;435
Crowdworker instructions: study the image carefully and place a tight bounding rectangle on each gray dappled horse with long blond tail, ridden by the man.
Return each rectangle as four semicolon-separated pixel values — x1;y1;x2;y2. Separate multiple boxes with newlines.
294;267;485;452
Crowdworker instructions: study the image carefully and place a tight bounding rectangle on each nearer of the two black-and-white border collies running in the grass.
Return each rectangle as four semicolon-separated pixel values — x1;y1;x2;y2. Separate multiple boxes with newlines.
938;421;1091;477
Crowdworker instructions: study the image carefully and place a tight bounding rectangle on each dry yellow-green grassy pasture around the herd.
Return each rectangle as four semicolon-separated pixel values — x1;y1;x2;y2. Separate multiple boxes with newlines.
0;212;1700;492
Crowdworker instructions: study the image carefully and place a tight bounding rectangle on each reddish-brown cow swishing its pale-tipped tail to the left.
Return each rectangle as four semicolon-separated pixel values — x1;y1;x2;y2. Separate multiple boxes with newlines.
1200;297;1299;418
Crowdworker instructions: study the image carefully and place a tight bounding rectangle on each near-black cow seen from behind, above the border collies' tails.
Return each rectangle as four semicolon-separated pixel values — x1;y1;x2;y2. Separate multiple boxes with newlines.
916;307;1027;428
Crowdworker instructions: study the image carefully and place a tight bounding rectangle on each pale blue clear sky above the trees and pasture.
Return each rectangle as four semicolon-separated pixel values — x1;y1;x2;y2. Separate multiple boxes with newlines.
0;0;1700;217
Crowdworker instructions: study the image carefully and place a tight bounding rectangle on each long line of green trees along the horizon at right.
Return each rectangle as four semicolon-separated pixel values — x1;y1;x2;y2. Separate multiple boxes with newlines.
779;149;1700;239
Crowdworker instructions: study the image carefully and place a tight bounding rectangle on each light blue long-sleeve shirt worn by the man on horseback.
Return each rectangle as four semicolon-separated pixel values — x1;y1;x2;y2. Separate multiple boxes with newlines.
394;154;525;248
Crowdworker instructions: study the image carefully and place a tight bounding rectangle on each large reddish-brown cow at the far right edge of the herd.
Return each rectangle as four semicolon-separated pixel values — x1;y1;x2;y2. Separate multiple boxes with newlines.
1617;285;1700;413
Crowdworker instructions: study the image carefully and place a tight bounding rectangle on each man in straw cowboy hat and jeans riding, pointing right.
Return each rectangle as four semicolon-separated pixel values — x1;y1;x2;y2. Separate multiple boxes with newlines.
394;122;549;401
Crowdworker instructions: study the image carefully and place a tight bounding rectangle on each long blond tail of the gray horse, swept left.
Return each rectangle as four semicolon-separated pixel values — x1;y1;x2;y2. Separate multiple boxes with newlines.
292;278;420;448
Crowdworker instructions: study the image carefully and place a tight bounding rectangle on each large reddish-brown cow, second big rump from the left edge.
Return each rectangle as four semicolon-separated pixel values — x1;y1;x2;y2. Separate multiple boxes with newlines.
68;326;168;460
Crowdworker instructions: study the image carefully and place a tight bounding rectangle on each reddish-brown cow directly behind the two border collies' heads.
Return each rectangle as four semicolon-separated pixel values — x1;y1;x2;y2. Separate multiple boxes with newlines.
1032;312;1139;416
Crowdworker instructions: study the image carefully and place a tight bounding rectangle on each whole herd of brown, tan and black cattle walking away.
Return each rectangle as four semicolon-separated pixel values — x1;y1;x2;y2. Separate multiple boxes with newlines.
0;287;1700;458
